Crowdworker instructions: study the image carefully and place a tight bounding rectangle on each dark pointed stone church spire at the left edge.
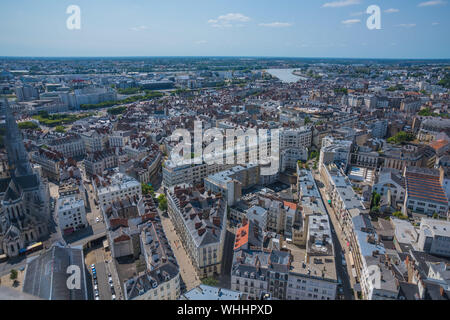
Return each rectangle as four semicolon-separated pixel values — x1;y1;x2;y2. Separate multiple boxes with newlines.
3;99;33;176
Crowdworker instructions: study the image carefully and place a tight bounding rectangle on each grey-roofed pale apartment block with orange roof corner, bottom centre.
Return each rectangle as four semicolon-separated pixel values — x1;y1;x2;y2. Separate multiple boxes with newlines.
231;220;338;300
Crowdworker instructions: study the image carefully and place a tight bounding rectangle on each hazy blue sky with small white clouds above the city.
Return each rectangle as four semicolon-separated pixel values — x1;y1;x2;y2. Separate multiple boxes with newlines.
0;0;450;59
